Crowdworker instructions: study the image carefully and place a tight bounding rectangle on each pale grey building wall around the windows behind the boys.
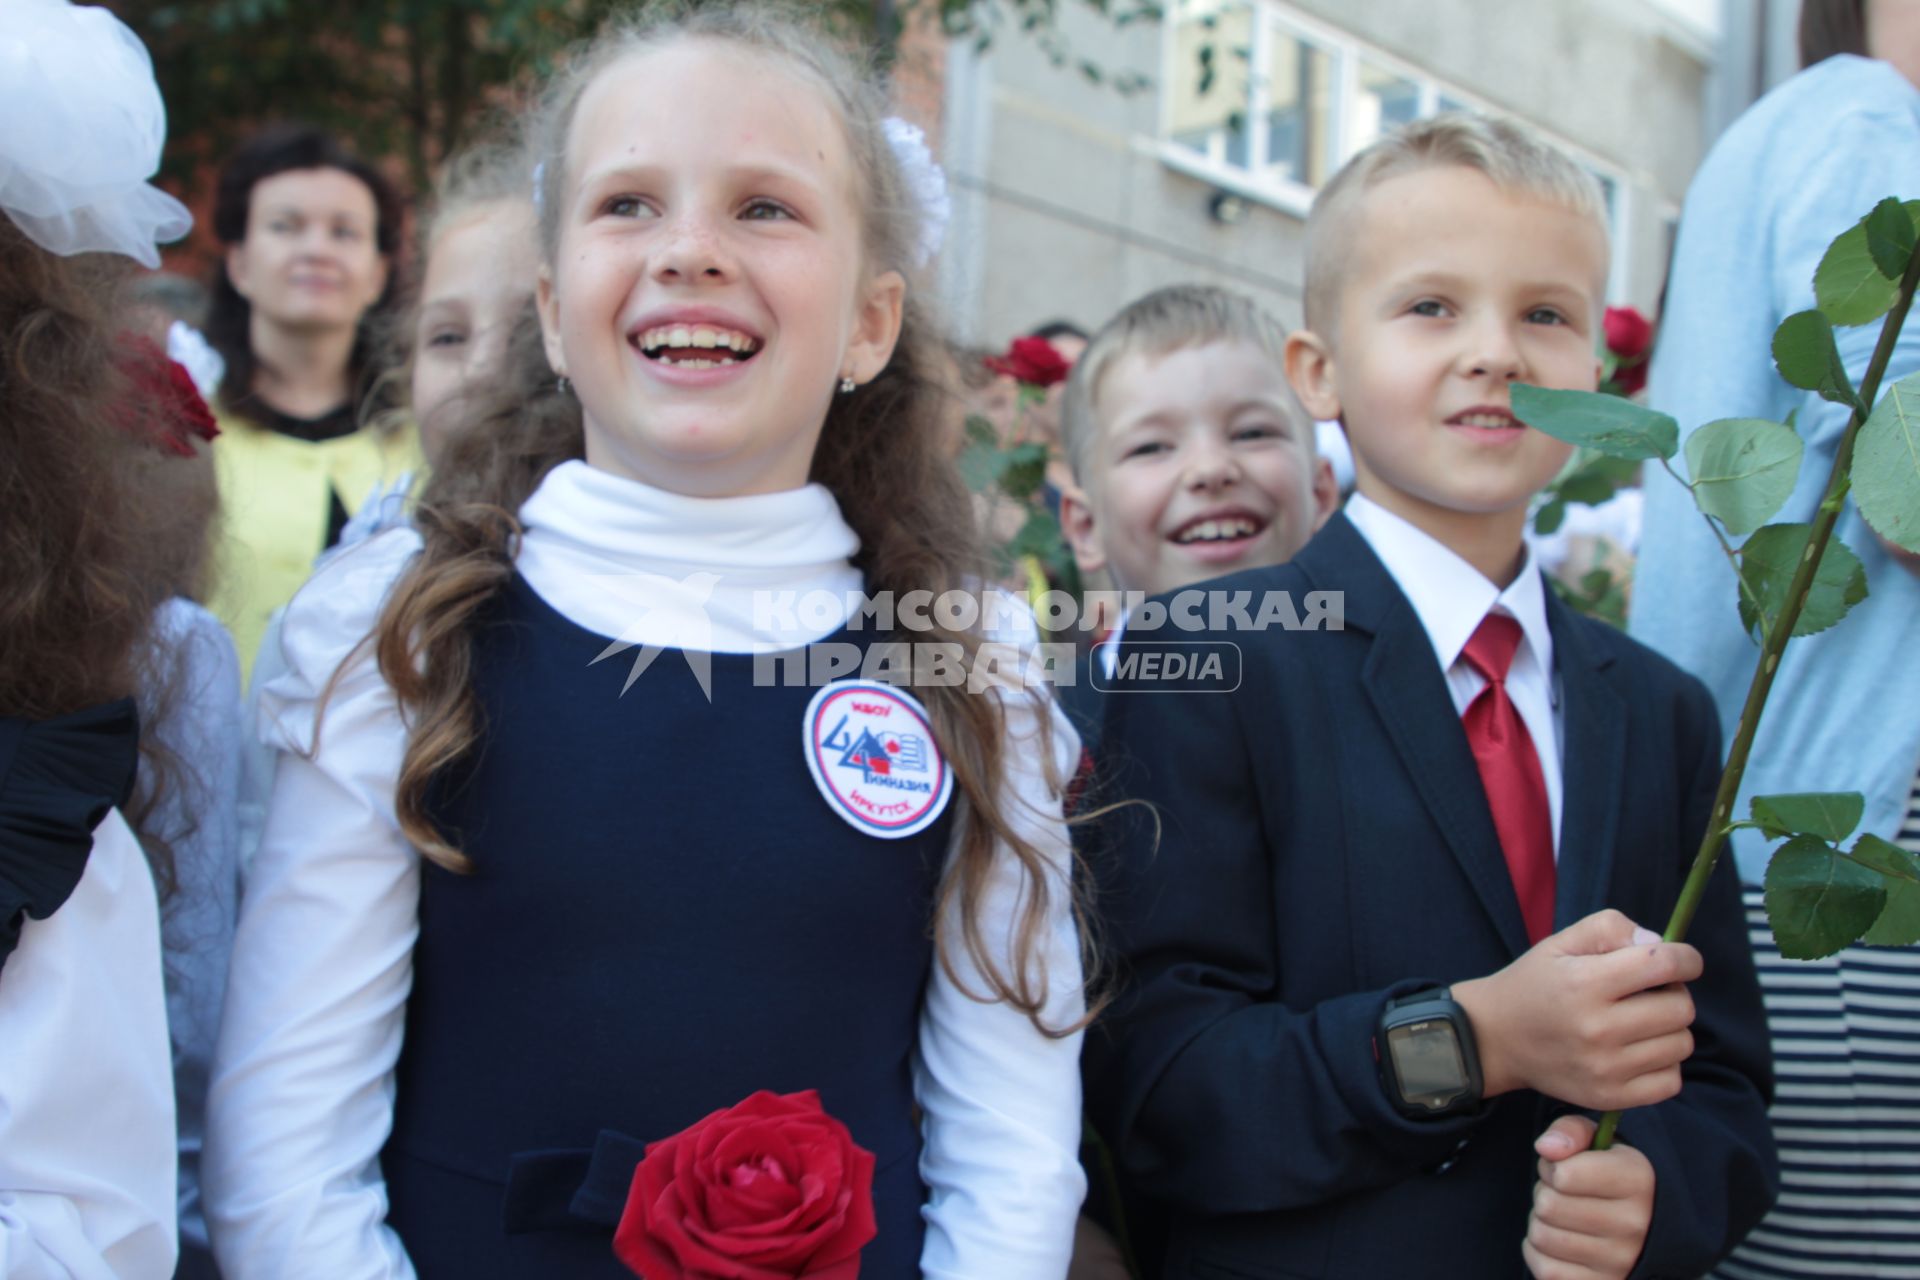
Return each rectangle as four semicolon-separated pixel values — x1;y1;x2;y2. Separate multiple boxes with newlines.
939;0;1720;344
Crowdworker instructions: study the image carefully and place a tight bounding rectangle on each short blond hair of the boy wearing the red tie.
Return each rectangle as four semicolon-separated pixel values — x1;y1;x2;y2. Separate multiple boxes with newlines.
1306;111;1607;336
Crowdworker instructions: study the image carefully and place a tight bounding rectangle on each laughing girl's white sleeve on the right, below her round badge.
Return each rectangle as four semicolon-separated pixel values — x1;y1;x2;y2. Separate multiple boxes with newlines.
914;612;1087;1280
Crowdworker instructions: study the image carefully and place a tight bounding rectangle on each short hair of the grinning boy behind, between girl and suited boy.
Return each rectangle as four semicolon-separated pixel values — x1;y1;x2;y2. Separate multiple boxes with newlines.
1060;284;1313;486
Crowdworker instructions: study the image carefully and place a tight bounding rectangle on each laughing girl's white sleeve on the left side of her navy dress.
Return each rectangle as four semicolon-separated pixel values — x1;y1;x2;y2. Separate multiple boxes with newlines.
202;530;420;1280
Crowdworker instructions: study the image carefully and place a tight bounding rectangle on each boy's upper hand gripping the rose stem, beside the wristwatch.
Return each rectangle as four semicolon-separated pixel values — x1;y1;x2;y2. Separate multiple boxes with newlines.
1453;912;1701;1111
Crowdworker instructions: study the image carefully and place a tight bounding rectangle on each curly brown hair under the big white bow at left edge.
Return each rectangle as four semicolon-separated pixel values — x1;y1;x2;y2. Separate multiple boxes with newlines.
0;217;215;887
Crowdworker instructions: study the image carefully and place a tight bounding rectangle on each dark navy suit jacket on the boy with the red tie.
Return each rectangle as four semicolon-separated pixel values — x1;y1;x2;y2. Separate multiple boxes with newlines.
1087;514;1778;1280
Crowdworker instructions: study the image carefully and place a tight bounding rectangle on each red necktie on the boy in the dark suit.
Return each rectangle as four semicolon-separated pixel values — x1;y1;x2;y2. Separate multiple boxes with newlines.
1461;614;1553;942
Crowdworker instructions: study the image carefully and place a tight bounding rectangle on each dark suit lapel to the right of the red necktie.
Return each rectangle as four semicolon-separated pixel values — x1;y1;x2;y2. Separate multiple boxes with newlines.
1548;587;1626;929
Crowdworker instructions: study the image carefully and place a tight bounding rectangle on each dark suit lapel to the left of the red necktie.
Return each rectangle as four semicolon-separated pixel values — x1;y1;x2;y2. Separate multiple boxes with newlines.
1296;514;1526;956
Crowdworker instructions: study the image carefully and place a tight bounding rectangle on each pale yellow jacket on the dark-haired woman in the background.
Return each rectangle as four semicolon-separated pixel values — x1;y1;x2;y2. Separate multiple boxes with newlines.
211;413;424;679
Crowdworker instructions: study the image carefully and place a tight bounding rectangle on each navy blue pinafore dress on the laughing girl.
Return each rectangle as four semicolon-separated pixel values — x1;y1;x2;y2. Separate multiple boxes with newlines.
382;576;952;1280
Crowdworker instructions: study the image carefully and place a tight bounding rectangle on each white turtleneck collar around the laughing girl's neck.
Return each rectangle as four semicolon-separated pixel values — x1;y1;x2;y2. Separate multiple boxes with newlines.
516;461;862;652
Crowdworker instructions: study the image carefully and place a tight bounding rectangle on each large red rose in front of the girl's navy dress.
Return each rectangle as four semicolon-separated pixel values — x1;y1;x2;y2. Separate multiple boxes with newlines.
612;1090;877;1280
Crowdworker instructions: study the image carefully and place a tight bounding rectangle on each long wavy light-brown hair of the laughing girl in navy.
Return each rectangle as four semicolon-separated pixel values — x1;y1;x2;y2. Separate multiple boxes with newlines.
362;4;1092;1036
